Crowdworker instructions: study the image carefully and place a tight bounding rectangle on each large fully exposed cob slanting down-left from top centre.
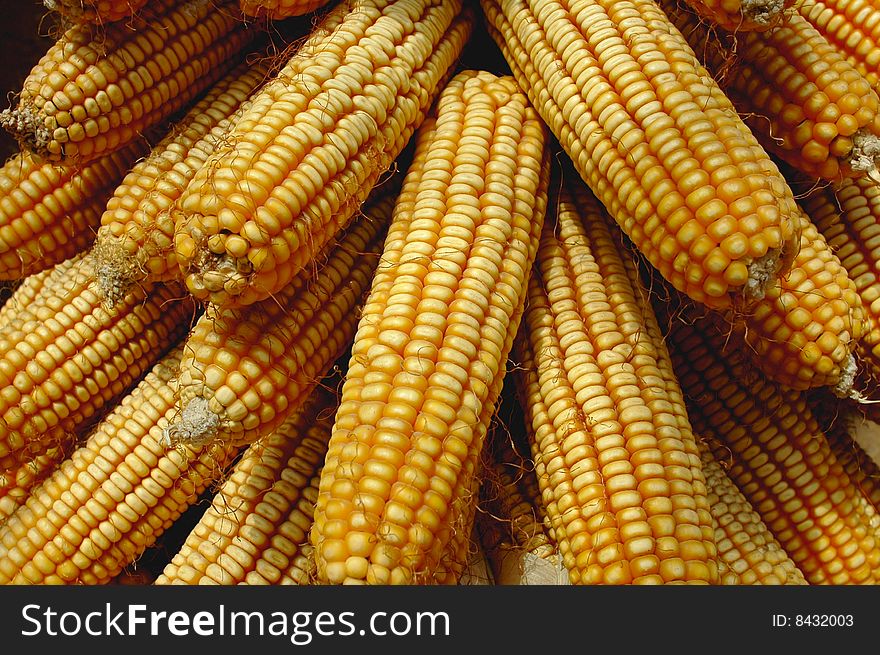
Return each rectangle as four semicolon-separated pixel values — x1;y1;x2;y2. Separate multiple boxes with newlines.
175;0;474;308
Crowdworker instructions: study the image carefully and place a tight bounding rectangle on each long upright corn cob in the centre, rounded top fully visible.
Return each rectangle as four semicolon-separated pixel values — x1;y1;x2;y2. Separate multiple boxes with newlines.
311;71;549;584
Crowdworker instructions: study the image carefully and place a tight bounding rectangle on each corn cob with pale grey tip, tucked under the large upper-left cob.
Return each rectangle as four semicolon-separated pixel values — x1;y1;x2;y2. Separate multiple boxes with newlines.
168;183;397;452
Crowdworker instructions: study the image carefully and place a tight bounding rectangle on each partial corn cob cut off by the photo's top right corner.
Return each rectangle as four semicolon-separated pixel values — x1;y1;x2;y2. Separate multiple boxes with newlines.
794;0;880;89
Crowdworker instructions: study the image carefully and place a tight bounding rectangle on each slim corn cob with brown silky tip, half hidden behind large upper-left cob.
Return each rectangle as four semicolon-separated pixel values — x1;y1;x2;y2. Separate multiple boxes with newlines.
95;59;270;304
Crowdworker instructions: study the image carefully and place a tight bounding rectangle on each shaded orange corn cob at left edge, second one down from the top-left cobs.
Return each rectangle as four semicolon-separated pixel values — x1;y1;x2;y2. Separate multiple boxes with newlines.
0;139;149;280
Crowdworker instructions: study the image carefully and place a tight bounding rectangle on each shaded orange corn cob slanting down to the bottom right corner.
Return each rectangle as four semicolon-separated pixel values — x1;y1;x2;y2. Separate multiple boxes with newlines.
655;298;880;584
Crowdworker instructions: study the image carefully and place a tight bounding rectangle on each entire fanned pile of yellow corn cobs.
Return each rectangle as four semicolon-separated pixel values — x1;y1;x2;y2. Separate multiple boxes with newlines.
0;0;880;584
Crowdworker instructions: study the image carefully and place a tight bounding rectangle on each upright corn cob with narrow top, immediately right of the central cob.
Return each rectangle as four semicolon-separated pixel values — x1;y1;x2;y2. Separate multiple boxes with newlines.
514;171;718;584
